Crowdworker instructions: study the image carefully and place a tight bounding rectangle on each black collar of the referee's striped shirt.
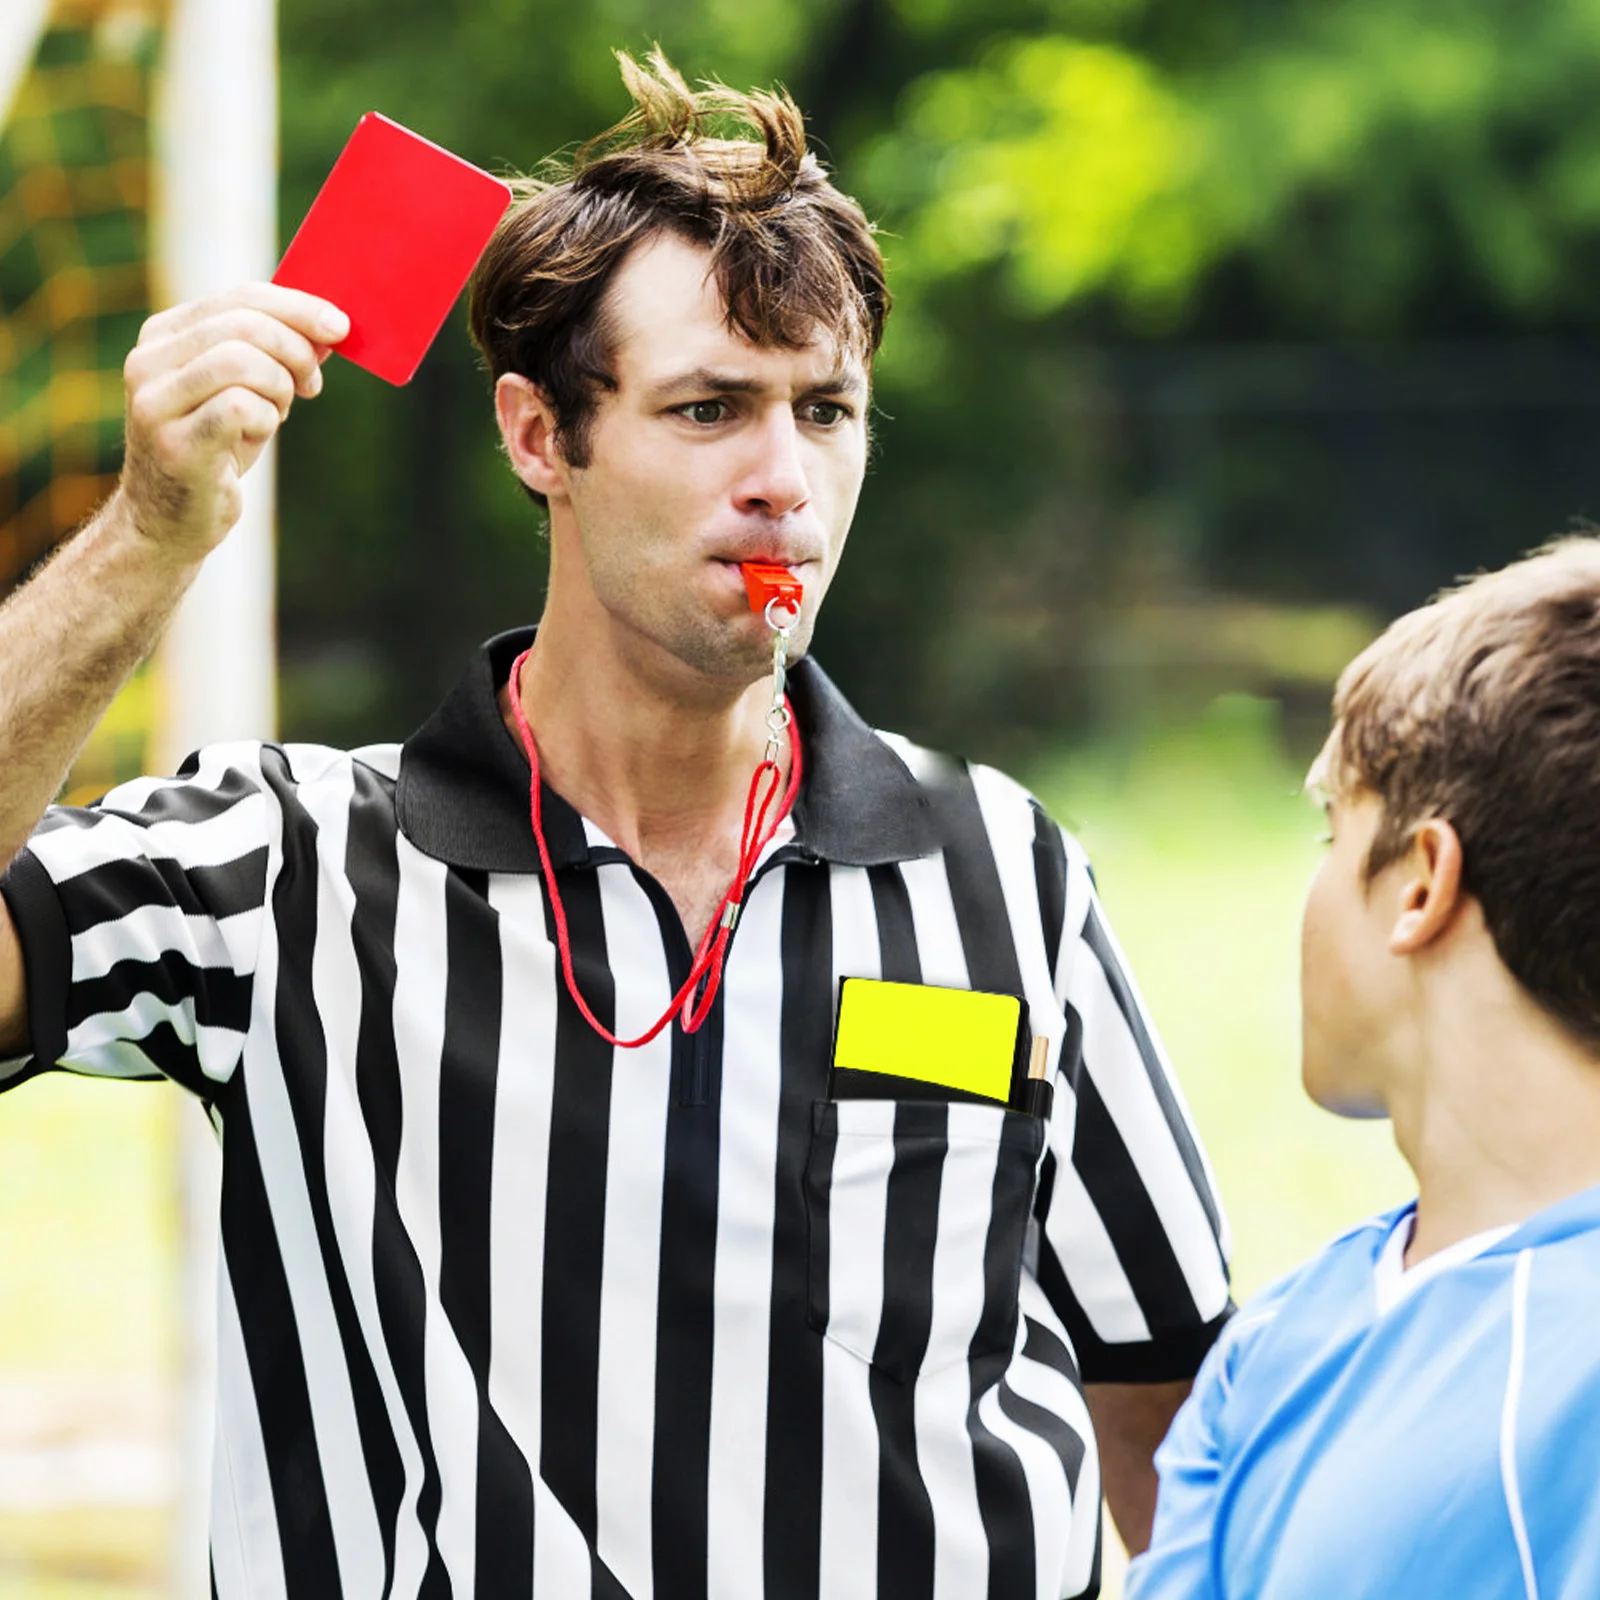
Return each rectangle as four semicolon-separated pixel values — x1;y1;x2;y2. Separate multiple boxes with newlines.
395;627;938;872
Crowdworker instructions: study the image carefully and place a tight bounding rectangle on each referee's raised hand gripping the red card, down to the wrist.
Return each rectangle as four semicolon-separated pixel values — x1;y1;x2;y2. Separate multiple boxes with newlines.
118;283;350;560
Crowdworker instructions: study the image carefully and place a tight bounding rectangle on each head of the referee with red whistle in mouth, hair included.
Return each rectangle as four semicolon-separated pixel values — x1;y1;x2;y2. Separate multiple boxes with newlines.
470;54;890;682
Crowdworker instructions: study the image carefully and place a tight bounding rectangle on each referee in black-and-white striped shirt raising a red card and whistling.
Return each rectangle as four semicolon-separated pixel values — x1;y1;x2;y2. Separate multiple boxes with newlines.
0;58;1229;1600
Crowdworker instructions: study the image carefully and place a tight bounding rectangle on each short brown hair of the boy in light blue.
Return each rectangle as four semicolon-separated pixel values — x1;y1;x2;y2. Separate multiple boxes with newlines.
1318;536;1600;1048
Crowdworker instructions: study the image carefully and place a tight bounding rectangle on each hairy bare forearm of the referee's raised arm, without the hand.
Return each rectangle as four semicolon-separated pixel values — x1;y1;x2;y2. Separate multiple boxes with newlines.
0;491;200;869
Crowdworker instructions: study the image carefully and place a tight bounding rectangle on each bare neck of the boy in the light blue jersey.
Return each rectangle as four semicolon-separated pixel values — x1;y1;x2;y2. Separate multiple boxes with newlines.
1390;970;1600;1266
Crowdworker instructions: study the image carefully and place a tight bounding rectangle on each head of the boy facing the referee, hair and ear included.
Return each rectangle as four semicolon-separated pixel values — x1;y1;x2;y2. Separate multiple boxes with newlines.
1302;538;1600;1114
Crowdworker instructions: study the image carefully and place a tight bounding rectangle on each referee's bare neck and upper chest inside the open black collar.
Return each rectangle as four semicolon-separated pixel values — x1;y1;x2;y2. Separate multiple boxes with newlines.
501;601;789;936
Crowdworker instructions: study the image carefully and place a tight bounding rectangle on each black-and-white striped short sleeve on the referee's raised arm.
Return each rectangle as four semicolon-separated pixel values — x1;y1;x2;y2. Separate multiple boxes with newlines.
0;744;274;1098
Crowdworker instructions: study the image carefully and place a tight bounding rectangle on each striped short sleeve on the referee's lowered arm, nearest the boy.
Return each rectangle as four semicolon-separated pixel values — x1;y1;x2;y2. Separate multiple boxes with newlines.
1035;813;1232;1382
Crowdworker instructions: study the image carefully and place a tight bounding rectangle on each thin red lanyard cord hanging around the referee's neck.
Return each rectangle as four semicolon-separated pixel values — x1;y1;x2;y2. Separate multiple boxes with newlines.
510;650;800;1050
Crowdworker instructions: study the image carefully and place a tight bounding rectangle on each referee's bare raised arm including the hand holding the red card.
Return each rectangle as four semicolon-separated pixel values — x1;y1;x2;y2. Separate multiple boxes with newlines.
0;283;349;1054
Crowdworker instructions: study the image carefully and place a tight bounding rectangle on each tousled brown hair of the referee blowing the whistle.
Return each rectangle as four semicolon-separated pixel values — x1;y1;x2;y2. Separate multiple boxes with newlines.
470;51;890;499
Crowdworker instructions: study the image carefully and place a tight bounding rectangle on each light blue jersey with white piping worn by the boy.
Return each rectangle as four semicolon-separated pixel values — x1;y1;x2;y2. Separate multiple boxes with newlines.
1126;1187;1600;1600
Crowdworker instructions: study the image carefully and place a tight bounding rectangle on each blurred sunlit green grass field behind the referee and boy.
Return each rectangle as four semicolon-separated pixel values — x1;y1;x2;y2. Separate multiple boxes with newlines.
0;699;1410;1600
